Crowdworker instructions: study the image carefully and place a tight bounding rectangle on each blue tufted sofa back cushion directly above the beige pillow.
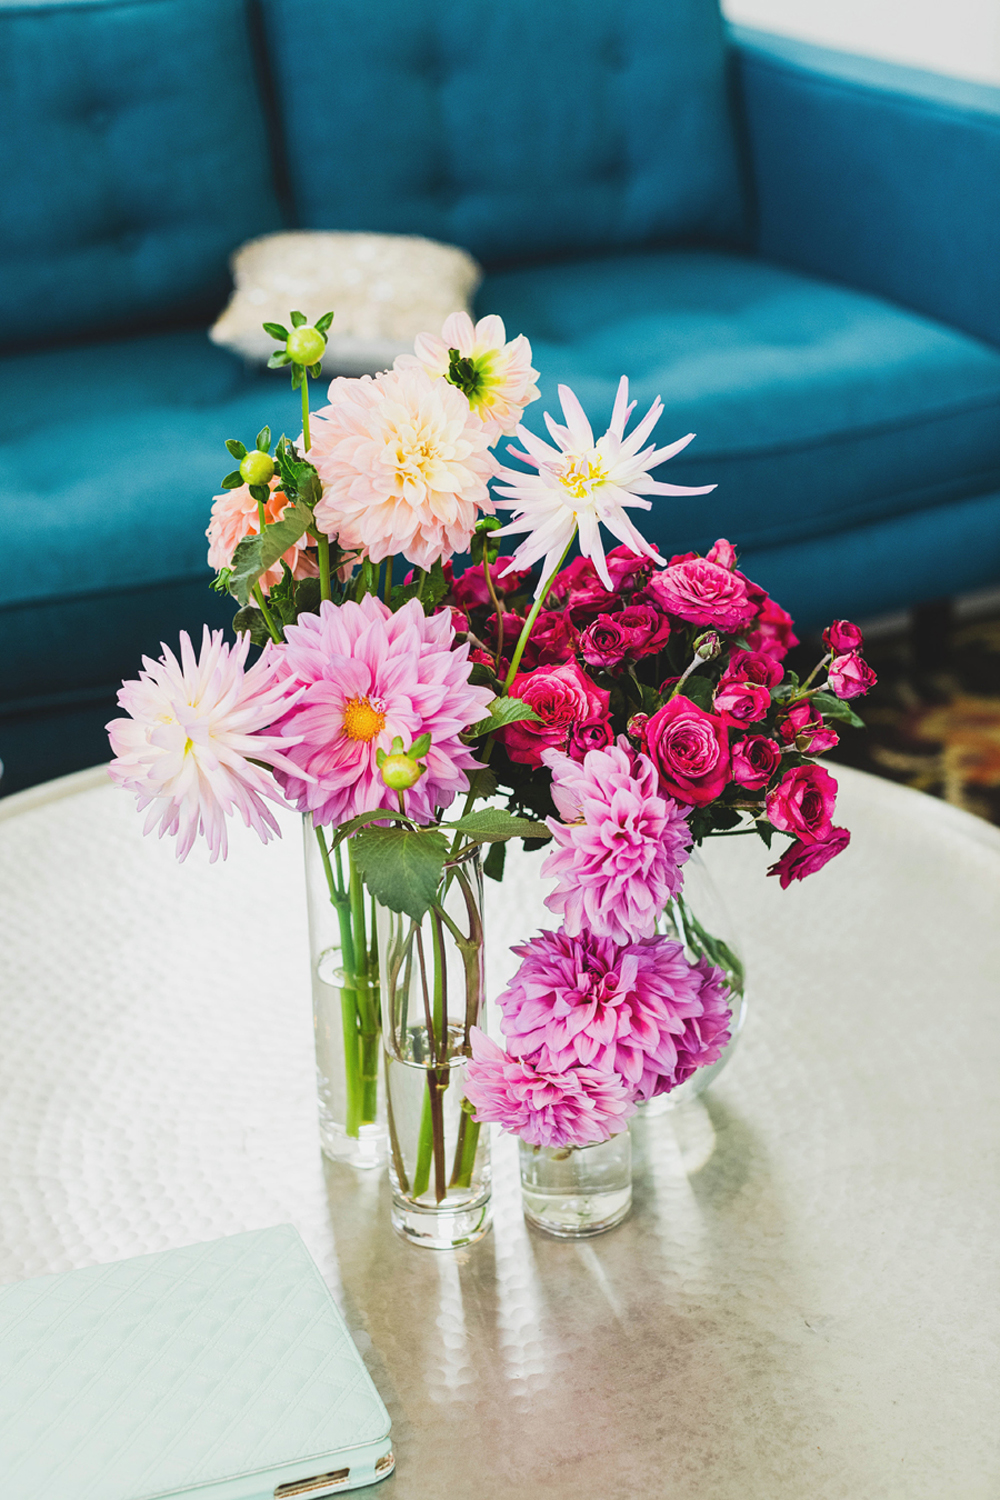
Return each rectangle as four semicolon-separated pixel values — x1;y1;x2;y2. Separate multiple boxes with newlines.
264;0;742;264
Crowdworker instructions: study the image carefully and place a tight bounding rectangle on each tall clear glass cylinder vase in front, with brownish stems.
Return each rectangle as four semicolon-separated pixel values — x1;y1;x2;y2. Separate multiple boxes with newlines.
376;849;490;1250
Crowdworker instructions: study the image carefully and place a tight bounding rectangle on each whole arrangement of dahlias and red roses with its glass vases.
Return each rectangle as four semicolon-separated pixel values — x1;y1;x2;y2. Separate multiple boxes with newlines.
108;301;873;1247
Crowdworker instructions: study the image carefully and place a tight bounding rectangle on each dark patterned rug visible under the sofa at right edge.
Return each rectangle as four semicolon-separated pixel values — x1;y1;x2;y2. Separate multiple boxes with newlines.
795;611;1000;824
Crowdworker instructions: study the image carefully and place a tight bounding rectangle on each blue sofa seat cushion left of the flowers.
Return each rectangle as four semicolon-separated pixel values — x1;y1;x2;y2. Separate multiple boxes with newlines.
0;329;301;704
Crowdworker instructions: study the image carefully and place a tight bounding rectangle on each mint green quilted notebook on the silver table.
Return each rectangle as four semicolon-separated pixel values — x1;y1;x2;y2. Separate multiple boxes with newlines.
0;1224;393;1500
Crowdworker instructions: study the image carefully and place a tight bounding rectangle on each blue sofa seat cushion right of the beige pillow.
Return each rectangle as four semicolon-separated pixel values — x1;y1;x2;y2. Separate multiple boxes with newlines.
477;251;1000;564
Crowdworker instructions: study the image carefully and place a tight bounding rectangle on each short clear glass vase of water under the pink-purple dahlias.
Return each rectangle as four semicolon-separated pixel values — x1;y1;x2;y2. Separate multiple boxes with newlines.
517;1130;633;1239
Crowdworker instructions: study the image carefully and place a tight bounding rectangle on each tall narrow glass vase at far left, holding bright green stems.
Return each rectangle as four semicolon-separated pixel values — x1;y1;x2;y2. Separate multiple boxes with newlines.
303;815;388;1170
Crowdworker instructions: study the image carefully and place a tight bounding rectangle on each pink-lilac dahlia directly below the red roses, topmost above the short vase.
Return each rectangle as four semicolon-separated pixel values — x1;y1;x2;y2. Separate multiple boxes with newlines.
541;746;691;944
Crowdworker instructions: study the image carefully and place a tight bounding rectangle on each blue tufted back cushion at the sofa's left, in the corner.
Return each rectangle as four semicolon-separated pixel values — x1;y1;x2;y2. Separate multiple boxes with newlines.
0;0;279;348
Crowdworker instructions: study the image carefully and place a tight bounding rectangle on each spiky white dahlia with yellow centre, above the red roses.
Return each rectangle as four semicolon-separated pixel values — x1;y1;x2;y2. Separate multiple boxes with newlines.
496;375;715;597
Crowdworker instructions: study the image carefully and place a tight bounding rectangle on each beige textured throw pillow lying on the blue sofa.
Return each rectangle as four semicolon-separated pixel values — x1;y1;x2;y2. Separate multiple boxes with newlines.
208;230;483;375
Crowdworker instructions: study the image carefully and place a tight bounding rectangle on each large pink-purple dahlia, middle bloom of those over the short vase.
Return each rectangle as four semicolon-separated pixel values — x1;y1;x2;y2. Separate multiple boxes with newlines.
499;929;729;1098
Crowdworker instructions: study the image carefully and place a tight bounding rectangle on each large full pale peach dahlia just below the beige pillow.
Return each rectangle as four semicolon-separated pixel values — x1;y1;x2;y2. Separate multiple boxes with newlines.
309;369;496;569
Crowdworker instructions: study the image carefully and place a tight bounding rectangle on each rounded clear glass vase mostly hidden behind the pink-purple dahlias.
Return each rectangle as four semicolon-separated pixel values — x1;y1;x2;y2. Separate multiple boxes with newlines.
650;849;747;1115
